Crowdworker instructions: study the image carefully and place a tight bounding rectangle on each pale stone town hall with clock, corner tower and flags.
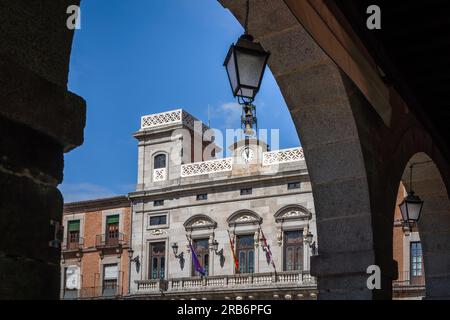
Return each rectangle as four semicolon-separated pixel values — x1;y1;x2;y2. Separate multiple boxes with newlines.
125;110;317;299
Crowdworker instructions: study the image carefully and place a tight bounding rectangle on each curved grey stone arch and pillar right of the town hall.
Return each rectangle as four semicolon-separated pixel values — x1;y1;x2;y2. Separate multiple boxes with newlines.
219;0;394;299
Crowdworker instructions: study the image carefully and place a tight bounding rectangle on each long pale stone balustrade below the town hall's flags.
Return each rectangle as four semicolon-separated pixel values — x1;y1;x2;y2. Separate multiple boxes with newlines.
136;271;316;293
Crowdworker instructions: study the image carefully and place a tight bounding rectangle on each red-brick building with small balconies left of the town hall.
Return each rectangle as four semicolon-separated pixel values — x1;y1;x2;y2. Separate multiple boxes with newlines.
61;196;131;299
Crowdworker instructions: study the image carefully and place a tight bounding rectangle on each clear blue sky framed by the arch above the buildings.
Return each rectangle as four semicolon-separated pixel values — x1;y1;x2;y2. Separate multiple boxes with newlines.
60;0;299;202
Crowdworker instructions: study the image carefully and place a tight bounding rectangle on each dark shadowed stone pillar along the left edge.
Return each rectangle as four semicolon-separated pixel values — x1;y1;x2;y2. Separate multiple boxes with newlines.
0;0;85;299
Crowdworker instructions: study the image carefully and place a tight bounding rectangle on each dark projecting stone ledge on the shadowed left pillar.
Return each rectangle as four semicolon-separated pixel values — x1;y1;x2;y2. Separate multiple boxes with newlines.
0;55;86;152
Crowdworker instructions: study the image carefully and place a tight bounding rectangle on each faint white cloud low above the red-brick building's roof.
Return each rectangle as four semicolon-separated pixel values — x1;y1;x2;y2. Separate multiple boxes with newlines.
59;182;118;203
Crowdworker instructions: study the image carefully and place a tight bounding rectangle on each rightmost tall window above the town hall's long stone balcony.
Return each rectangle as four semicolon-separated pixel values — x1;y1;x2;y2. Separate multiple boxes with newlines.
284;230;303;271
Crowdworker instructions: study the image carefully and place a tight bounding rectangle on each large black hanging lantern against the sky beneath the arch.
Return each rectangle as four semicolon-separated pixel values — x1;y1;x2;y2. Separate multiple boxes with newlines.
224;0;270;135
